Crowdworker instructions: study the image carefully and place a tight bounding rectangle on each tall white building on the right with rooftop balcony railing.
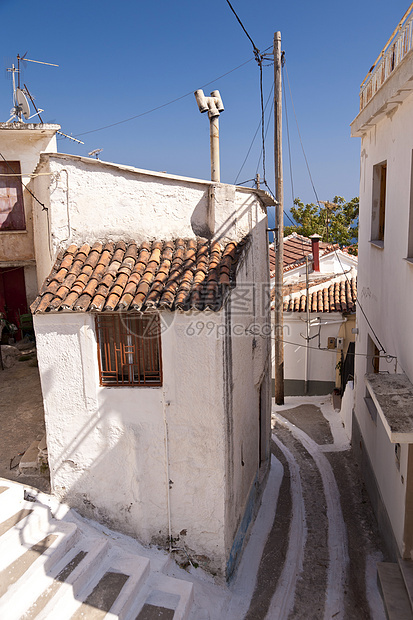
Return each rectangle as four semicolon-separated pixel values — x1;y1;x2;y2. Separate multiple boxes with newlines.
351;8;413;559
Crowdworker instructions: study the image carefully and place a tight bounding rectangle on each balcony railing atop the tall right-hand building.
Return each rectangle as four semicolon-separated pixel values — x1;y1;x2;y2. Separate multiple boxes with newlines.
360;3;413;112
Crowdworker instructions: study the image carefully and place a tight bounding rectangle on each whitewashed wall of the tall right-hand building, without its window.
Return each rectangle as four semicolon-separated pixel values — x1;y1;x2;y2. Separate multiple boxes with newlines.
352;61;413;553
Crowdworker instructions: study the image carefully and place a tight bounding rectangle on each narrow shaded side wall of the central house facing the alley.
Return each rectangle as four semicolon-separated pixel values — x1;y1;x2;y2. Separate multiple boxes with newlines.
221;218;271;565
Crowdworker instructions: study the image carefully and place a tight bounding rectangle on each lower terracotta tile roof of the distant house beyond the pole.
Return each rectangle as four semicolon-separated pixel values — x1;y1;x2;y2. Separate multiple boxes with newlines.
283;277;357;312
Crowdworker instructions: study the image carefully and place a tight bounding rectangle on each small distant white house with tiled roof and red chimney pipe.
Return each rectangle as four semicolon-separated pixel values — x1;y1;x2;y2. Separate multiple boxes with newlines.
270;233;357;396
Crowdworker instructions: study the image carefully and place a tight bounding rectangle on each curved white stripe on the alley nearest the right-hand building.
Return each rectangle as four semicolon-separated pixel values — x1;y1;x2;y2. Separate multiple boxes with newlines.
275;414;349;620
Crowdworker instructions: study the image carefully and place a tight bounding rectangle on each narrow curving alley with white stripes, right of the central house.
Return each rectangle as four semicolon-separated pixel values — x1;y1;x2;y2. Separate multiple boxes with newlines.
237;396;385;620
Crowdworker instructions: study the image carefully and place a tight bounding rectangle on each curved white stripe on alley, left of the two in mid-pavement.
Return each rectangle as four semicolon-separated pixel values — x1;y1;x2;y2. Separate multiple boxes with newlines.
266;435;307;620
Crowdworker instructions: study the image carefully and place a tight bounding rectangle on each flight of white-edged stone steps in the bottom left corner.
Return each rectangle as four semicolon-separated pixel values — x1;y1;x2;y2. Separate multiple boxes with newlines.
0;479;194;620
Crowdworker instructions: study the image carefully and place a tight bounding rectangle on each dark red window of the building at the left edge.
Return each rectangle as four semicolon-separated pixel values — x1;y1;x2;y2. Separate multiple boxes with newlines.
0;161;26;230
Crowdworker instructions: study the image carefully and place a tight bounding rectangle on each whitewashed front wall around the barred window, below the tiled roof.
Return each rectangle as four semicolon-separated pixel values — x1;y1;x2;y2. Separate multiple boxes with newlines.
34;313;227;571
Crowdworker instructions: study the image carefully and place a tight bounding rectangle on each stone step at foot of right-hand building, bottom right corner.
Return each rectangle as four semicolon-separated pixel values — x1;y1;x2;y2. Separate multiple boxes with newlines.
377;562;413;620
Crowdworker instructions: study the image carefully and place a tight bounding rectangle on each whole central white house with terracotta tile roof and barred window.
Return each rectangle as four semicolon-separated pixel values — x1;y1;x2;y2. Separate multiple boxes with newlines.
32;154;273;577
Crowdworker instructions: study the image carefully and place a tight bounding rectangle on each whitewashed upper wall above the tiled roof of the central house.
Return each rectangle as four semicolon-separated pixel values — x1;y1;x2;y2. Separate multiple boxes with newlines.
34;154;268;278
